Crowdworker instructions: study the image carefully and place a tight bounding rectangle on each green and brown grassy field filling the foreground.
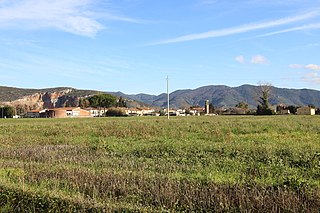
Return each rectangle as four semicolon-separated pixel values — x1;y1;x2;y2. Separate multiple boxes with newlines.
0;116;320;212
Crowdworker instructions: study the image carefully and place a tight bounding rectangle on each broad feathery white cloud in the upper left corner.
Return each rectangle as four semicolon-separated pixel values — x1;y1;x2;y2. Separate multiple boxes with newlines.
0;0;138;37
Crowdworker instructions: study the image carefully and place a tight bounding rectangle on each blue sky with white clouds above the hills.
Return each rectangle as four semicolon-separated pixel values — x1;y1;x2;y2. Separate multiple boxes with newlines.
0;0;320;94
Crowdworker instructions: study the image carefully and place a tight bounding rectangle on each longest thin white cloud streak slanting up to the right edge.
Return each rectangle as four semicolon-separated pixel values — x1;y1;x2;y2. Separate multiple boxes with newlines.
153;9;320;45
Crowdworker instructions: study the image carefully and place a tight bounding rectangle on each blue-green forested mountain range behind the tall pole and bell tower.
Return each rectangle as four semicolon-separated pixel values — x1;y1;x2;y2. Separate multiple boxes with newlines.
119;85;320;108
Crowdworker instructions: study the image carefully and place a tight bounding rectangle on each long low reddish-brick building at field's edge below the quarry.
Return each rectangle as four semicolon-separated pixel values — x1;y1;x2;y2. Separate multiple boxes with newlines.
45;107;91;118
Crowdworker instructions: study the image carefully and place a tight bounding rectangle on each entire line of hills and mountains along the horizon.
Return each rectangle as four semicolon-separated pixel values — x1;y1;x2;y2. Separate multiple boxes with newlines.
0;85;320;108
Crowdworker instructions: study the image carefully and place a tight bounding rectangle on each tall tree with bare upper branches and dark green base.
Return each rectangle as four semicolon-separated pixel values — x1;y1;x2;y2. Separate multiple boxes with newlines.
257;84;273;115
